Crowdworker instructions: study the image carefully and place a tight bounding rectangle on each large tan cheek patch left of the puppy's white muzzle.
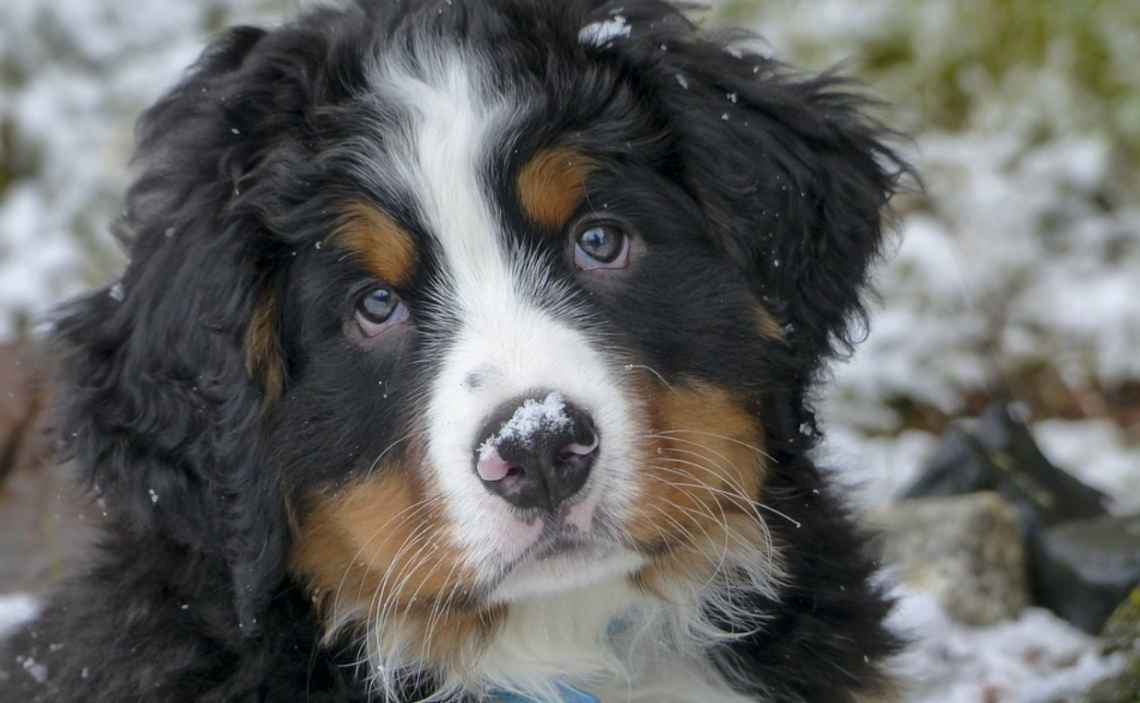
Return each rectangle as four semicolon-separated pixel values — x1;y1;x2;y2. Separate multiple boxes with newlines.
290;465;506;667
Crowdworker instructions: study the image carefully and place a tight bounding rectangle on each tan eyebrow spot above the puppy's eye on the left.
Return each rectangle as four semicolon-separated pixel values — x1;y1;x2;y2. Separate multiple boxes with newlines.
334;203;416;286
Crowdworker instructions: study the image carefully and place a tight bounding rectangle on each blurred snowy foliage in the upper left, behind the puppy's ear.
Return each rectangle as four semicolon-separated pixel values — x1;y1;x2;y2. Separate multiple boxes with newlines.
0;0;298;338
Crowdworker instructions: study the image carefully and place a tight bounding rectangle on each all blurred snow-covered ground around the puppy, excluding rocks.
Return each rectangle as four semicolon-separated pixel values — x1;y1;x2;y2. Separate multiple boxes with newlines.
0;0;1140;703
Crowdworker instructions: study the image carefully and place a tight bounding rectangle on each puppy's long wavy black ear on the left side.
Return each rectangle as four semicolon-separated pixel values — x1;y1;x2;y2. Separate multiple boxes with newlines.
56;28;307;630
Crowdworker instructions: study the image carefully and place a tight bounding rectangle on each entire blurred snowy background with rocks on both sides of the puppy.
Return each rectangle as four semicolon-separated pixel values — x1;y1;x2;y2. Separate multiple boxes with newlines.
0;0;1140;703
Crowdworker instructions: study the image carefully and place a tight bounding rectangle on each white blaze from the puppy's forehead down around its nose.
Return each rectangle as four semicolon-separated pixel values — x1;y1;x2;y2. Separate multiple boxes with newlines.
375;47;635;590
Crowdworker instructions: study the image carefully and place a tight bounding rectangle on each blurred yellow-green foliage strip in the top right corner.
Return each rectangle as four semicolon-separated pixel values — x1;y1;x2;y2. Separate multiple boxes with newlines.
715;0;1140;190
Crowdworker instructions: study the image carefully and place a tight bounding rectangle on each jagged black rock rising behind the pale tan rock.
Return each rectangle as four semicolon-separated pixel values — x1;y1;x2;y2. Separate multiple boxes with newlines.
903;404;1106;538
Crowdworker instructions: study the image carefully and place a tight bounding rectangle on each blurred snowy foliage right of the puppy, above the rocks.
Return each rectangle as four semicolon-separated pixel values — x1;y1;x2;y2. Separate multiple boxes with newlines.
709;0;1140;436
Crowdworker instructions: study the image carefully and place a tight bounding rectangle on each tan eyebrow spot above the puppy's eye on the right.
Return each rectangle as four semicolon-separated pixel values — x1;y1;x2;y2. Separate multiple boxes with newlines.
518;147;594;230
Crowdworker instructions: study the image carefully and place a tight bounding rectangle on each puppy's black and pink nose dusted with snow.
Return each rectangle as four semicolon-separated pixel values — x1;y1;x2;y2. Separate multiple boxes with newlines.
475;392;601;510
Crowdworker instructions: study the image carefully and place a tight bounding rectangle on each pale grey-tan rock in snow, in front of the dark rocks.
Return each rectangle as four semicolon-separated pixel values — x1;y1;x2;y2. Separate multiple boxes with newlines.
869;492;1028;626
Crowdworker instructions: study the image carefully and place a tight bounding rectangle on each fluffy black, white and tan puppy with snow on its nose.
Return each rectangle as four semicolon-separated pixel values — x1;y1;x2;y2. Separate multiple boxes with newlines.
0;0;906;703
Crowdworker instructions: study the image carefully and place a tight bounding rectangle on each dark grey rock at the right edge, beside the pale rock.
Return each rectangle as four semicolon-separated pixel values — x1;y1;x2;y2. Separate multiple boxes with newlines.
1033;514;1140;632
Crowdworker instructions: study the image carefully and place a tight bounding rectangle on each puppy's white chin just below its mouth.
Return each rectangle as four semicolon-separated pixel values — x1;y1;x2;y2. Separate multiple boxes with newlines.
489;538;645;603
